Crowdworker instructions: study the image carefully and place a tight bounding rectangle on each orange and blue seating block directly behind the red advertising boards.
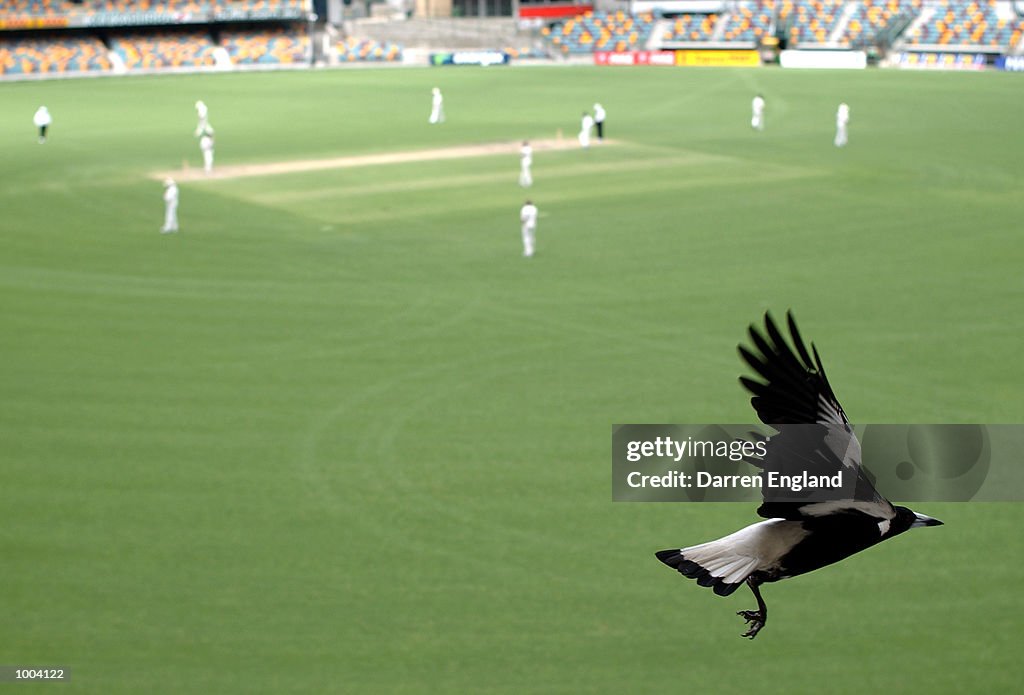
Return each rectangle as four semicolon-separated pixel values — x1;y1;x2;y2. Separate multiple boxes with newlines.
542;11;654;53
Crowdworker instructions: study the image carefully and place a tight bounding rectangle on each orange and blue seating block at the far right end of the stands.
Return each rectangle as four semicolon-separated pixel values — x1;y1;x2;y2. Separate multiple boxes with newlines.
904;0;1024;51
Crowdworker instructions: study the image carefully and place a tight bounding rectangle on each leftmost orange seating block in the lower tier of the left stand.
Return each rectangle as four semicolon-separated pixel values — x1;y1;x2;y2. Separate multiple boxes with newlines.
0;36;111;75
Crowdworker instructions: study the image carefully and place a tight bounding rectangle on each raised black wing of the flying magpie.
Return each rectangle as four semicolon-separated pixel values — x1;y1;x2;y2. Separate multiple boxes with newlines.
739;312;896;521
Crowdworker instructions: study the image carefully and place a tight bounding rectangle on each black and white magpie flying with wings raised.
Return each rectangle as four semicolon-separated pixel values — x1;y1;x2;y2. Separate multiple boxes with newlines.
656;313;942;640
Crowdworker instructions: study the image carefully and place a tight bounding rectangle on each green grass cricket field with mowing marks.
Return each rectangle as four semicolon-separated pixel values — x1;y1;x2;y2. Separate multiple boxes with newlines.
0;69;1024;695
